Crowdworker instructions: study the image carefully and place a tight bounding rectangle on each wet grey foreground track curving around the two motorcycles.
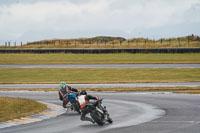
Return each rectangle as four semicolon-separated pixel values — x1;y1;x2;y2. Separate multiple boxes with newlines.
0;91;200;133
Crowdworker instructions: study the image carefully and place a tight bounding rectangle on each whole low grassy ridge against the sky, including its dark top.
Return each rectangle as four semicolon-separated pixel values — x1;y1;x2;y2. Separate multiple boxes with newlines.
1;34;200;48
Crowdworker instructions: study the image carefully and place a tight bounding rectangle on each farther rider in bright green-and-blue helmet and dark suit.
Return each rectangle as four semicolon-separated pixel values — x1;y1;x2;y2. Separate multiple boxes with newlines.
59;82;78;108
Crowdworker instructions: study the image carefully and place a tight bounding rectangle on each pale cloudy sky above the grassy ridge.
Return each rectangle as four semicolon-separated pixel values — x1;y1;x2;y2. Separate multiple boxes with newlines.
0;0;200;44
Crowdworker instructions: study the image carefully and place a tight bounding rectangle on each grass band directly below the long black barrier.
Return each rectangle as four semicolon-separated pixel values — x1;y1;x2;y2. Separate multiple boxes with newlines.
0;53;200;64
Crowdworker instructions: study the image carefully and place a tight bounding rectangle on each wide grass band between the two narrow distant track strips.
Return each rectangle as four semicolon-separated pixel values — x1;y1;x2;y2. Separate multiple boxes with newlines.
0;68;200;84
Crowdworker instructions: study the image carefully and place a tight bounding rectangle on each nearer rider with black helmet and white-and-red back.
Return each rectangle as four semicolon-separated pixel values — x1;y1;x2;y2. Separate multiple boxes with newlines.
78;90;98;123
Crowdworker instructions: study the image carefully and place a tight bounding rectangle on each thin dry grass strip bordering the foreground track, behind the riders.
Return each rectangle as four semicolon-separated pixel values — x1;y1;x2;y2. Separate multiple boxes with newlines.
0;87;200;94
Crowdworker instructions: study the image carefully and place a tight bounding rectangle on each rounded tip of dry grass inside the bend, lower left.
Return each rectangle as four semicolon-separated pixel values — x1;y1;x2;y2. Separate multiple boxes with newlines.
0;97;47;122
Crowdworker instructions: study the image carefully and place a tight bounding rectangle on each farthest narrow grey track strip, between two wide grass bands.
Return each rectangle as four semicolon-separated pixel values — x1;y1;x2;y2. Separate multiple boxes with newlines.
0;64;200;68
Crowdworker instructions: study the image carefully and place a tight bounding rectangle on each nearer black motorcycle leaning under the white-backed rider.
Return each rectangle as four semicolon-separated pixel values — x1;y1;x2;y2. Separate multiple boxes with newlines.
87;99;113;126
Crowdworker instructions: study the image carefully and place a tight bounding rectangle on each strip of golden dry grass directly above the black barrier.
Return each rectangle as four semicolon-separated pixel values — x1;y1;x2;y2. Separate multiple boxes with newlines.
0;41;200;49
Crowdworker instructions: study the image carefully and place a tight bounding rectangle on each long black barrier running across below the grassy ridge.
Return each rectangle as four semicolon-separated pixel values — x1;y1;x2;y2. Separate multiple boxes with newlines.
0;48;200;54
